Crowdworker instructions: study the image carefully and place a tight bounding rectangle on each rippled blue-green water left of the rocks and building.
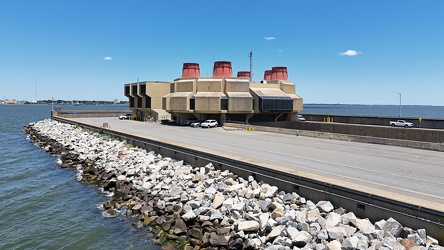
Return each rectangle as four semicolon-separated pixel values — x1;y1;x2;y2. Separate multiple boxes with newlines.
0;105;160;249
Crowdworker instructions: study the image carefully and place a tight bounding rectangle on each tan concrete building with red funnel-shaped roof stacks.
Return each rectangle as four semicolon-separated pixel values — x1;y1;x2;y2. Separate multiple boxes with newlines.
124;61;302;124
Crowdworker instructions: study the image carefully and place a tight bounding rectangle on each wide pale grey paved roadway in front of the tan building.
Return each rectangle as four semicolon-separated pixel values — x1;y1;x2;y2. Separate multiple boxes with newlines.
70;117;444;211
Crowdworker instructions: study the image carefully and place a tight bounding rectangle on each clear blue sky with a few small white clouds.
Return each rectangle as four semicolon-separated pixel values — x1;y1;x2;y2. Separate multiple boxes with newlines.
0;0;444;106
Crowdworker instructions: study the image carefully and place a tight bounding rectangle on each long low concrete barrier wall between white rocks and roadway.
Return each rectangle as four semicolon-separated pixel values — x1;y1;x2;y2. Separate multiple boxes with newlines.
53;117;444;244
